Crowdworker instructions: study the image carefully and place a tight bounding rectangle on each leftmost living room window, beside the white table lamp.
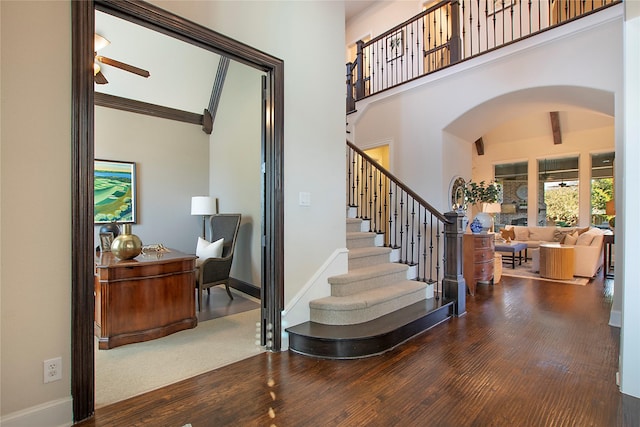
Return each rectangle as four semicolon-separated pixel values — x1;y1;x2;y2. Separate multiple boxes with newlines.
494;162;528;230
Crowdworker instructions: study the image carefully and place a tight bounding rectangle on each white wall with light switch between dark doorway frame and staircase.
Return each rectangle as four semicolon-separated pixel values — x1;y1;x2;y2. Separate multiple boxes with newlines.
154;1;346;304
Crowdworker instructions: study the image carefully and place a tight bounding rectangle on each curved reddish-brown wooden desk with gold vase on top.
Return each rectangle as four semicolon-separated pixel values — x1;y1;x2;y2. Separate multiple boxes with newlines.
94;250;198;350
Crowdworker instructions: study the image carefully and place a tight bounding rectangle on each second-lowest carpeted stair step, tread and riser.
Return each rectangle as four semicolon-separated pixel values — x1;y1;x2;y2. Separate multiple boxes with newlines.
327;262;409;297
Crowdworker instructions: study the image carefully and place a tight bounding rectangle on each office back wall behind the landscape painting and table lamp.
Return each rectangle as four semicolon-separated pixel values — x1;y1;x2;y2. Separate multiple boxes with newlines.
94;107;209;253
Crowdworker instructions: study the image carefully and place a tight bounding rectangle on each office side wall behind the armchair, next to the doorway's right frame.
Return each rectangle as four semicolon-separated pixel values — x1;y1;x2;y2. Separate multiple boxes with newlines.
209;61;264;286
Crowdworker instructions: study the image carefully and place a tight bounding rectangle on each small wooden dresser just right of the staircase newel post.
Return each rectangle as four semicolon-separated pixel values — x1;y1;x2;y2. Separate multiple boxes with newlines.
462;234;495;295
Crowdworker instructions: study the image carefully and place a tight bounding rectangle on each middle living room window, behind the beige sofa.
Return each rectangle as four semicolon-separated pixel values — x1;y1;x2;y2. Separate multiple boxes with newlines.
538;156;580;227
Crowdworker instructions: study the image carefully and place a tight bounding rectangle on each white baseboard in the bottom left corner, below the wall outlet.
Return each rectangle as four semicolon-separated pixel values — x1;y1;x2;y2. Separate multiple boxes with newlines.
0;397;73;427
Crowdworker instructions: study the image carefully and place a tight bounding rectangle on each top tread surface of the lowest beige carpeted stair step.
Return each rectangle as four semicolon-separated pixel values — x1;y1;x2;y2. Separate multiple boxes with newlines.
309;280;428;311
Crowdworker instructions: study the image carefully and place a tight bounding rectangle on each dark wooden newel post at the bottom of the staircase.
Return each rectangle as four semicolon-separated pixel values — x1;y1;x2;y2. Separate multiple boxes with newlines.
442;211;467;316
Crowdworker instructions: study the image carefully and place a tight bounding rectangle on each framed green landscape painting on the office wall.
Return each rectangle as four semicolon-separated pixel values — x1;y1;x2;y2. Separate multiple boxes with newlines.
93;159;136;224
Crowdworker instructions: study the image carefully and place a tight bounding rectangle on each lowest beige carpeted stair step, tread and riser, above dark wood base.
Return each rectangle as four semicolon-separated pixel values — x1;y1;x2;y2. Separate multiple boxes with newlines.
309;280;428;325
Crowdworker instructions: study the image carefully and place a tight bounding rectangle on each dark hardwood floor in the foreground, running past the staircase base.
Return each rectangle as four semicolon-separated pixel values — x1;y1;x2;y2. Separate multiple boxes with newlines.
78;275;640;427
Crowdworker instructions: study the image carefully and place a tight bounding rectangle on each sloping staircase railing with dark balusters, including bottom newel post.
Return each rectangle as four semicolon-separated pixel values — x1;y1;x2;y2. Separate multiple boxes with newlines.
347;141;466;314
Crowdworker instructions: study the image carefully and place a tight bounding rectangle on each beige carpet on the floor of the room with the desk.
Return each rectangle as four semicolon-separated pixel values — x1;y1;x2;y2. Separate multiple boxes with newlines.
95;309;263;407
